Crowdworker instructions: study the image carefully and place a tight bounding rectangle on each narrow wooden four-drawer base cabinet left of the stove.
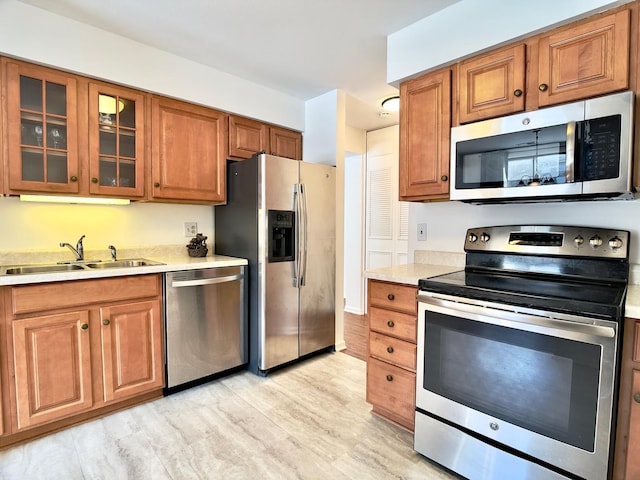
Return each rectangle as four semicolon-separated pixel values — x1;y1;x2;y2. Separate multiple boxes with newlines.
367;280;417;430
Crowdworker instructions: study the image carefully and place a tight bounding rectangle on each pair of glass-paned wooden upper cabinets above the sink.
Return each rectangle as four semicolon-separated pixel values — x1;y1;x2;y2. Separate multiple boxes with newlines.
2;59;145;198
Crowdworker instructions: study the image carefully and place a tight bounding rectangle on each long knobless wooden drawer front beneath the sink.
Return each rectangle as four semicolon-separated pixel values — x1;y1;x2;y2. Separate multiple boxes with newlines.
11;275;162;315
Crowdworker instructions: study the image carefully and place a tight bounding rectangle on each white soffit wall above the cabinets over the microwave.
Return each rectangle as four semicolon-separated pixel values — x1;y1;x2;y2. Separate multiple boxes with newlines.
387;0;632;86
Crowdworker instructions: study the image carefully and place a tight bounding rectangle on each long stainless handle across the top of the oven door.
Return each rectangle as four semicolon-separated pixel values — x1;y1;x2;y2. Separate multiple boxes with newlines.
418;294;616;339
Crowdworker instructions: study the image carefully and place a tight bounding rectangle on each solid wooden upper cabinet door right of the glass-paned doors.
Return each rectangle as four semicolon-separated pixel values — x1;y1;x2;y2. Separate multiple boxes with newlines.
150;96;227;204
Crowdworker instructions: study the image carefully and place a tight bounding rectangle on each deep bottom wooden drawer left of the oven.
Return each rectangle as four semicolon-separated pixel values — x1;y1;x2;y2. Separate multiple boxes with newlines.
367;357;416;425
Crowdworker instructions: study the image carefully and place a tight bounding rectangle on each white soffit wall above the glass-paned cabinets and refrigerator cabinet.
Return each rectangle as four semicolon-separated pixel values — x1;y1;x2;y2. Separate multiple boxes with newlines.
0;0;304;131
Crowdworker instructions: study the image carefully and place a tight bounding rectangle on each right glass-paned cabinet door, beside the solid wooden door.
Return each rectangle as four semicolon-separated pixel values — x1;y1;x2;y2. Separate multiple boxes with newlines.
89;83;145;197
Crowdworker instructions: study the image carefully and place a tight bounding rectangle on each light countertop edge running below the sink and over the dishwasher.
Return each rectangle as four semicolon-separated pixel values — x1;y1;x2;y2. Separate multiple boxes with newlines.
0;255;249;286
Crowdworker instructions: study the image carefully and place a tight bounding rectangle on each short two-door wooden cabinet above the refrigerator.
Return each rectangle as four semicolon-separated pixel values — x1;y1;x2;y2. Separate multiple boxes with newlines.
229;115;302;160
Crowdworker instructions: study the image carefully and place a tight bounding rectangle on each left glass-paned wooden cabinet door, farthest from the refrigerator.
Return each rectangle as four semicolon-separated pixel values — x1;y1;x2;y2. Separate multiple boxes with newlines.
6;61;79;193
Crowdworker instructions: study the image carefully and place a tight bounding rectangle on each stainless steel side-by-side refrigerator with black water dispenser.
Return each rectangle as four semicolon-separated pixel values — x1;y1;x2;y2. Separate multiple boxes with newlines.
215;154;336;374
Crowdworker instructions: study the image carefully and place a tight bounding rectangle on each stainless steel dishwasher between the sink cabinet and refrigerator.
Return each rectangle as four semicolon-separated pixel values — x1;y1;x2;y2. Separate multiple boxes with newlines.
164;266;248;394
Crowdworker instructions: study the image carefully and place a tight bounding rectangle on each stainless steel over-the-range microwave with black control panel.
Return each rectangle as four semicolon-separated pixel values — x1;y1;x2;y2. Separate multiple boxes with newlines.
450;91;634;203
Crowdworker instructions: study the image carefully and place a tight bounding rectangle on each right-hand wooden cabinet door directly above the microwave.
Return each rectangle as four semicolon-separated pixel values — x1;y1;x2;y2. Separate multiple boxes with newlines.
536;9;630;107
